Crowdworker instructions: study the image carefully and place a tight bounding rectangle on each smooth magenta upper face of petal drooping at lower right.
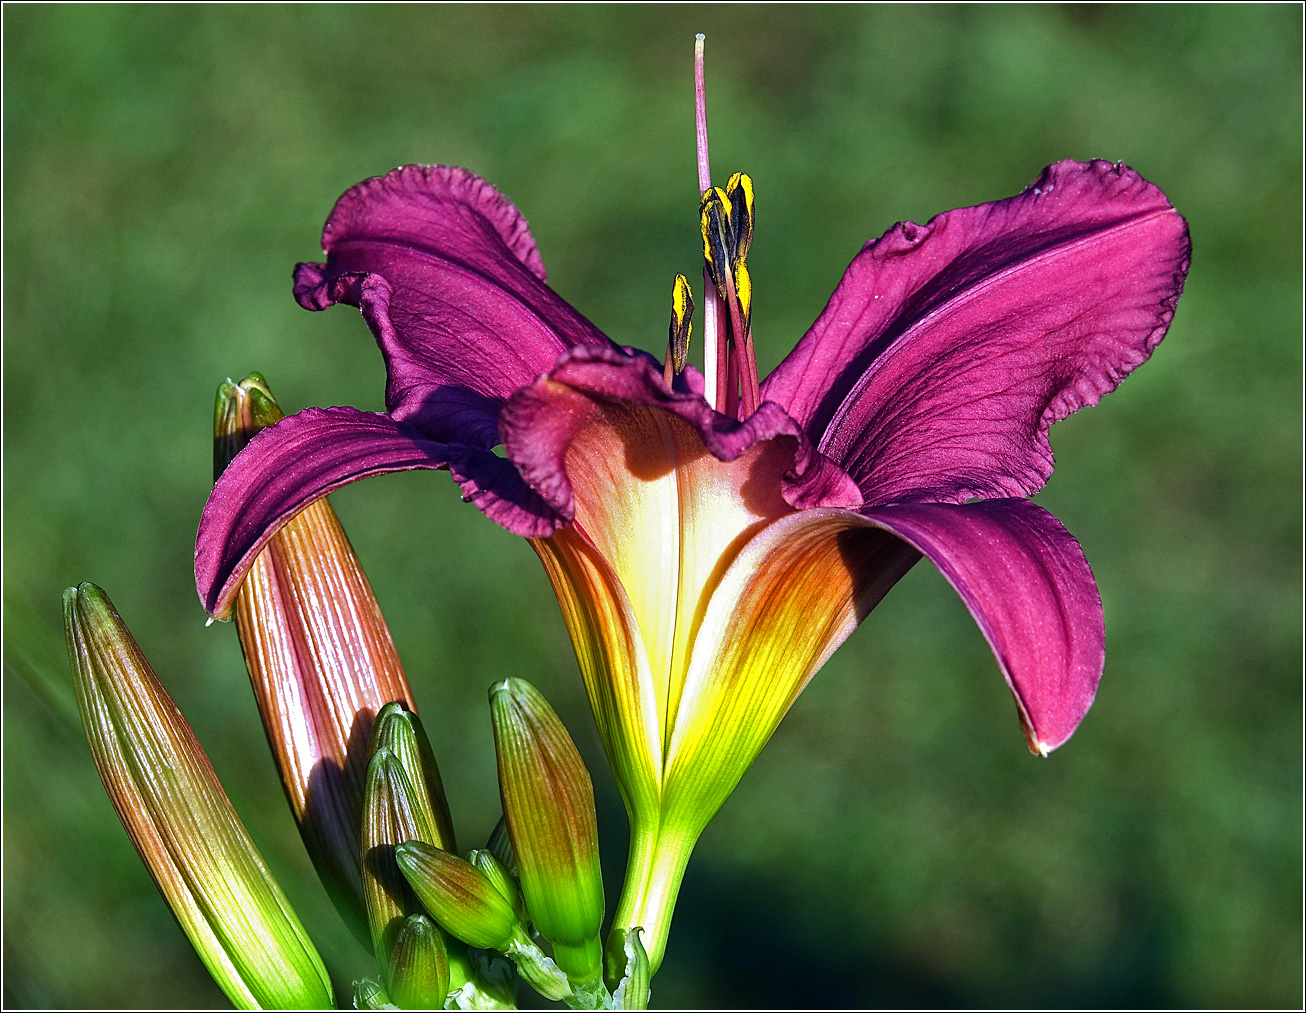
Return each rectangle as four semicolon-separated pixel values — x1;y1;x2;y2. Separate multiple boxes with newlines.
862;500;1105;755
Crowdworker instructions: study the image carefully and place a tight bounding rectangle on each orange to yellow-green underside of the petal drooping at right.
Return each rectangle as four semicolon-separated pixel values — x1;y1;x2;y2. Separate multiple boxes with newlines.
663;509;919;833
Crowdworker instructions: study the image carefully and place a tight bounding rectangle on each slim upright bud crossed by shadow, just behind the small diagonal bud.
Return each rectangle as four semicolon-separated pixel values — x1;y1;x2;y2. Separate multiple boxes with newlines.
363;749;435;982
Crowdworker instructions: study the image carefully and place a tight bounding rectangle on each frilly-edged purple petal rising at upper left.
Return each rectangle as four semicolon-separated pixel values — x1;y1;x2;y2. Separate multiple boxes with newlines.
295;166;610;446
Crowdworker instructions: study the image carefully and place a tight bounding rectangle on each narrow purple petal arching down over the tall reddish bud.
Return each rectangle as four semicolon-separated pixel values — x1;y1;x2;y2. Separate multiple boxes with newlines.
195;407;558;619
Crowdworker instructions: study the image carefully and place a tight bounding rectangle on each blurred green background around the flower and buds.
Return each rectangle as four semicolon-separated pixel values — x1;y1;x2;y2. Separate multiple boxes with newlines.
4;5;1302;1008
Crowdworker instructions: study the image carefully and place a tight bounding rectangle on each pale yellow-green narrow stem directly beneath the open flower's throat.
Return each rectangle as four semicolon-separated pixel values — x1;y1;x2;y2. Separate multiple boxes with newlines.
607;821;699;974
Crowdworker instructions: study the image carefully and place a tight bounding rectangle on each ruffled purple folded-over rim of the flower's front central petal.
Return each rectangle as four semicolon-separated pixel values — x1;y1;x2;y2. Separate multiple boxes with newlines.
499;349;862;522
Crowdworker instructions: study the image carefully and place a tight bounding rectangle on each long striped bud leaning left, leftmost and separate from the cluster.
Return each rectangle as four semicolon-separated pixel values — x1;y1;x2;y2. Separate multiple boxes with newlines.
64;584;333;1009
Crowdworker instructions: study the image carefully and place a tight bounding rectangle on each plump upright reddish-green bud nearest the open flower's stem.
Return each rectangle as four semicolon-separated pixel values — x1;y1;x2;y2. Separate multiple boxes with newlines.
490;679;603;982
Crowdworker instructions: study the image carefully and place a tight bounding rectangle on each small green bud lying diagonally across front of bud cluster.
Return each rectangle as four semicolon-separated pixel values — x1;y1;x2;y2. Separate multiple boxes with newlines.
394;841;521;950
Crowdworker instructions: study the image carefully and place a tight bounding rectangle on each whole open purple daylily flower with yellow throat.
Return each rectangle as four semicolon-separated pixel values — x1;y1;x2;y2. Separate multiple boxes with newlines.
196;81;1190;970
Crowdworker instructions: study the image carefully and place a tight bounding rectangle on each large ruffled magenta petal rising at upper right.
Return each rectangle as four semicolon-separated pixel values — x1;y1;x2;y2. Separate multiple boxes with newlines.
761;162;1190;504
